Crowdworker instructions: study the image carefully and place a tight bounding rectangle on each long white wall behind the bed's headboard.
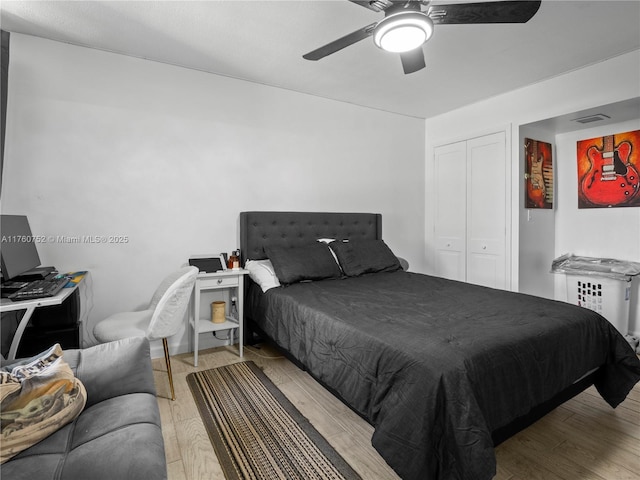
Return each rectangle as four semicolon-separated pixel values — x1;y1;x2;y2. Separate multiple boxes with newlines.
2;34;424;351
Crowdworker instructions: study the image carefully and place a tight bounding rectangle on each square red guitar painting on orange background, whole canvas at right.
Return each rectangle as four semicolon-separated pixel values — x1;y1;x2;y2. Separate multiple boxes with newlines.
578;130;640;208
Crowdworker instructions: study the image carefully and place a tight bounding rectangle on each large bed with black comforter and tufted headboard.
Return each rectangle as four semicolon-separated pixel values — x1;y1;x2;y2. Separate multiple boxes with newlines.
240;212;640;480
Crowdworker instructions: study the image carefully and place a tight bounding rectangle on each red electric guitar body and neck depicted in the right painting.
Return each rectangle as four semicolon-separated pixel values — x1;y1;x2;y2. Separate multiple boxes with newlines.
580;135;639;206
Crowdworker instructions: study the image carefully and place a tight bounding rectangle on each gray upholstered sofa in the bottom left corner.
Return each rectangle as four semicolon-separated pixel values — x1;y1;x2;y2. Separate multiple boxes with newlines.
0;337;167;480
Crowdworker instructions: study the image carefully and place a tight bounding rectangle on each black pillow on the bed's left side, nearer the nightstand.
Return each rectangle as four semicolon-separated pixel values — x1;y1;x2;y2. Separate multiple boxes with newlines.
265;242;341;284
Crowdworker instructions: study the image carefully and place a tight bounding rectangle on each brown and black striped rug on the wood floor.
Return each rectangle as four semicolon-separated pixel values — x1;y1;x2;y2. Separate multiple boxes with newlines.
187;361;360;480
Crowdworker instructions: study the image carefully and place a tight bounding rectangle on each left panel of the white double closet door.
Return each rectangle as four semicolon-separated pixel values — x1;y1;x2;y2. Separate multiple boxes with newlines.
434;142;467;281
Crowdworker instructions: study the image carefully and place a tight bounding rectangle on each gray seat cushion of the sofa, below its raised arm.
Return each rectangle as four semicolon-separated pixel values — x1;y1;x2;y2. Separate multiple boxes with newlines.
2;393;167;480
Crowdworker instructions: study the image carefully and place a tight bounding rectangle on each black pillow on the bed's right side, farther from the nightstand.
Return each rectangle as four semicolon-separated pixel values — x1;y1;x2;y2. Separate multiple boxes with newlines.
329;240;402;277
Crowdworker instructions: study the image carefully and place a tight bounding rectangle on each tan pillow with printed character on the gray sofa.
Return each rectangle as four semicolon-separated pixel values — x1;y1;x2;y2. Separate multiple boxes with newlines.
0;344;87;463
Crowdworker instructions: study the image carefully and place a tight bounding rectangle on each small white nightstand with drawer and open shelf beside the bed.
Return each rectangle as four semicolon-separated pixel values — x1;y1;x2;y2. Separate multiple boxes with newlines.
189;269;249;367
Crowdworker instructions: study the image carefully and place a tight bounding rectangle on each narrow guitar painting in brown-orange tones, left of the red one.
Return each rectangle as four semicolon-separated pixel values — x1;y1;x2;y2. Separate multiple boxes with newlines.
524;138;553;208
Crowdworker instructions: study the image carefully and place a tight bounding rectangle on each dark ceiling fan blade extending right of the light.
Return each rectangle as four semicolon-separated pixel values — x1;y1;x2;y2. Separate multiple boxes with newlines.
428;0;541;25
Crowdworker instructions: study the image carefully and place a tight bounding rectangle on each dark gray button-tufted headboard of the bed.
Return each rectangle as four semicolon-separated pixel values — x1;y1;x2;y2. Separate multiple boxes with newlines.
240;212;382;263
